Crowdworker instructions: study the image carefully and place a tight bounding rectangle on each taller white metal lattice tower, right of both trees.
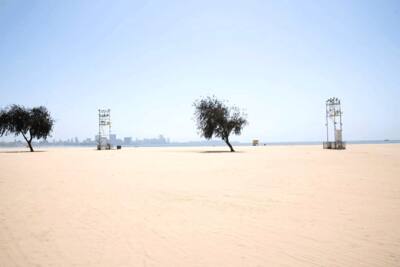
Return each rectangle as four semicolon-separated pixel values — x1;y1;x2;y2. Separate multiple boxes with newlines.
324;97;345;149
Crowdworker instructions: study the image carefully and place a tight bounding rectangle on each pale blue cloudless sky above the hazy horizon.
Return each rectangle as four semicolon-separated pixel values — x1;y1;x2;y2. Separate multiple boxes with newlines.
0;0;400;142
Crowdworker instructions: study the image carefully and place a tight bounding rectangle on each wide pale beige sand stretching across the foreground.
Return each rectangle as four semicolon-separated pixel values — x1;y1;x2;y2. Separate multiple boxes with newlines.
0;145;400;267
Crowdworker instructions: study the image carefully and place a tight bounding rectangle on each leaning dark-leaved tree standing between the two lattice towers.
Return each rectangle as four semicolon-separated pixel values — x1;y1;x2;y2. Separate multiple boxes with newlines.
193;96;247;152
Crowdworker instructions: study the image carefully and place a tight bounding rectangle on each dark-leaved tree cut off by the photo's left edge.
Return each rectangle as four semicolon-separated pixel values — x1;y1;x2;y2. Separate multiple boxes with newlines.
0;105;54;152
